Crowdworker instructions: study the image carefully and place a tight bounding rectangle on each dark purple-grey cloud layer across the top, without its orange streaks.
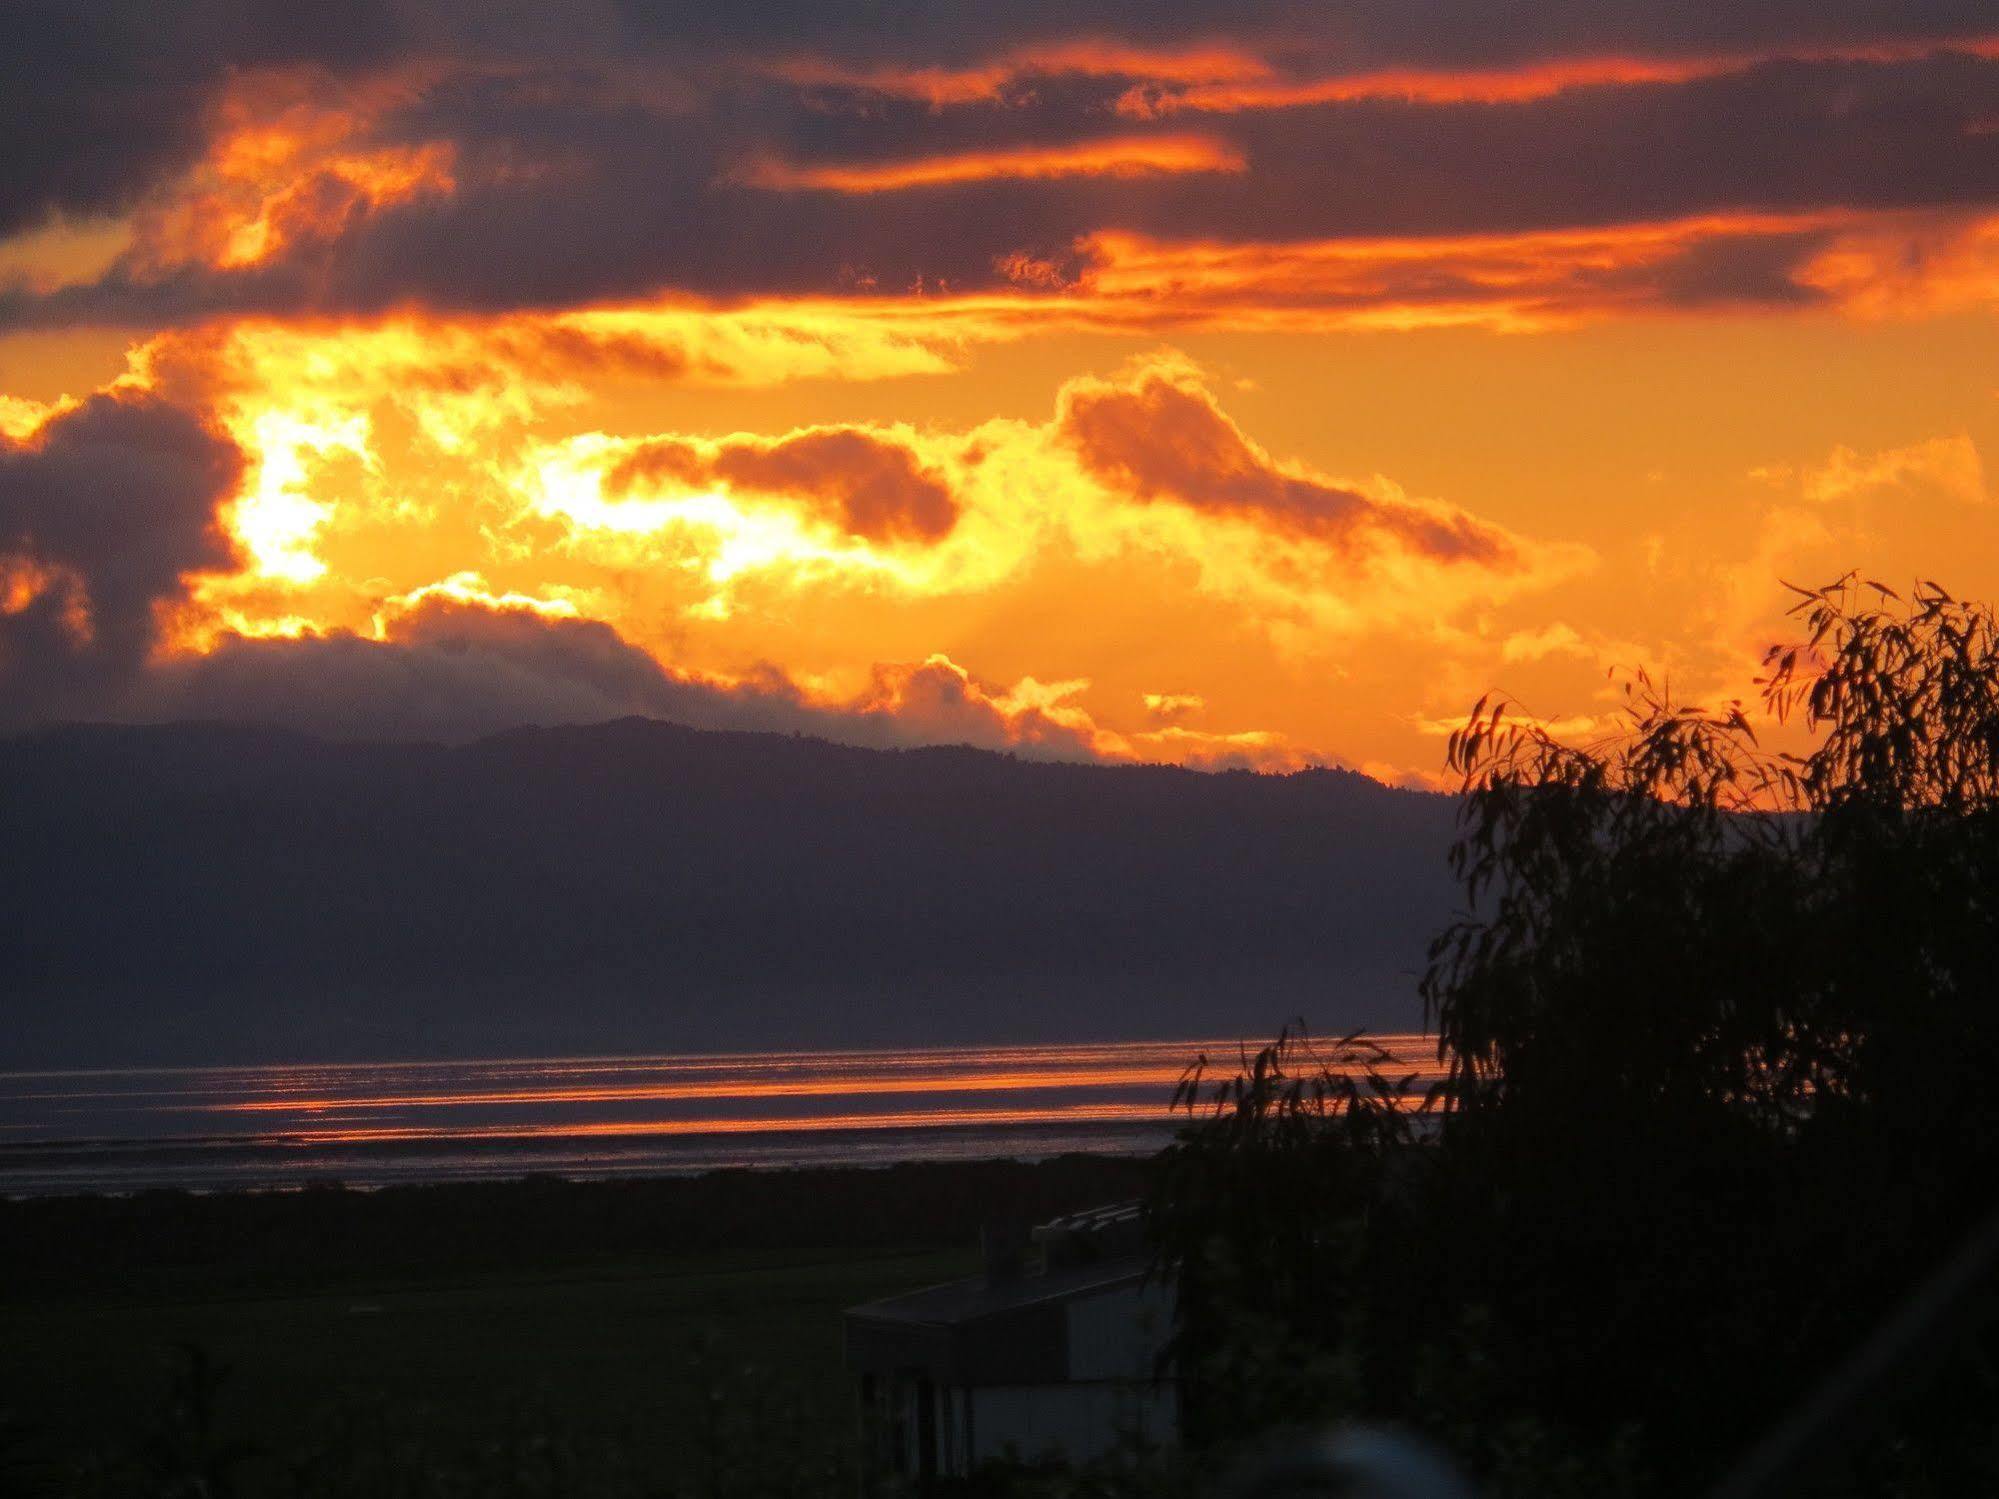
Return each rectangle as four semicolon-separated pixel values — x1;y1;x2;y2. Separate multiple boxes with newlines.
0;0;1999;328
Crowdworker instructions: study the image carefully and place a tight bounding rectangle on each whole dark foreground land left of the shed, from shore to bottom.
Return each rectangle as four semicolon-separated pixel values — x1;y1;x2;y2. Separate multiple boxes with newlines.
0;1157;1143;1495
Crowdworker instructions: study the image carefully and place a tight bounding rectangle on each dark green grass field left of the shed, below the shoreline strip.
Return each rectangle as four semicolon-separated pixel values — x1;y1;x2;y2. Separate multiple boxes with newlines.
0;1249;974;1493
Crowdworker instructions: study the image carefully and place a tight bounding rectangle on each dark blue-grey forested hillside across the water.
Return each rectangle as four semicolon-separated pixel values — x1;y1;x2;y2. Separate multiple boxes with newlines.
0;720;1451;1065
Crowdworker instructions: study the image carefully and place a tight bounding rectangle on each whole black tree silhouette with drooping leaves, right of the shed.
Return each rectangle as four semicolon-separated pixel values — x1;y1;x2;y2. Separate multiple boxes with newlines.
1155;576;1999;1493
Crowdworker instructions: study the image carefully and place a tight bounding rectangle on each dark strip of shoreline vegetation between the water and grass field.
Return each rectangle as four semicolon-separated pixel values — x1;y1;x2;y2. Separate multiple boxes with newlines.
0;1153;1151;1303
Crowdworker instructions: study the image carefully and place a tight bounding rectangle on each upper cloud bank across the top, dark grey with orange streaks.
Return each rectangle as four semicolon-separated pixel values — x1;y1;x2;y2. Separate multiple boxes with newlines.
0;0;1999;328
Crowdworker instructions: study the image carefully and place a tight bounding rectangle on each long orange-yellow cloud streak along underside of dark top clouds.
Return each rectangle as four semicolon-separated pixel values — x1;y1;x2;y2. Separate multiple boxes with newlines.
375;208;1967;353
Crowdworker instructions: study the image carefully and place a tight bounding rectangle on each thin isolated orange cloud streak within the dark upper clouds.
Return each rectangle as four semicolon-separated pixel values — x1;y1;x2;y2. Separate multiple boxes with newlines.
738;134;1247;194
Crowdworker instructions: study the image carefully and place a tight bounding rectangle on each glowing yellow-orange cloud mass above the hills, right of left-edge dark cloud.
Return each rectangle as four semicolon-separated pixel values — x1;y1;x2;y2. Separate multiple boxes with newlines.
4;314;1577;769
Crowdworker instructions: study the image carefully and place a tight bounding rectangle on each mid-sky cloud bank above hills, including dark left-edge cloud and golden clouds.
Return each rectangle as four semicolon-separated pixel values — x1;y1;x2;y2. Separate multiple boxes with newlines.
0;353;1503;769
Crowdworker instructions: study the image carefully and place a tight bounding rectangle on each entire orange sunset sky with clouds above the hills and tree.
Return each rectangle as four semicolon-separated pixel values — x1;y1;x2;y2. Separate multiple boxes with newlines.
0;0;1999;783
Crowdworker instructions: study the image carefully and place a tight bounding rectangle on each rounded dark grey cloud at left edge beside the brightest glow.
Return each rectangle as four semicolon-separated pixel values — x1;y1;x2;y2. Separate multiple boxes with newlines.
0;396;242;720
